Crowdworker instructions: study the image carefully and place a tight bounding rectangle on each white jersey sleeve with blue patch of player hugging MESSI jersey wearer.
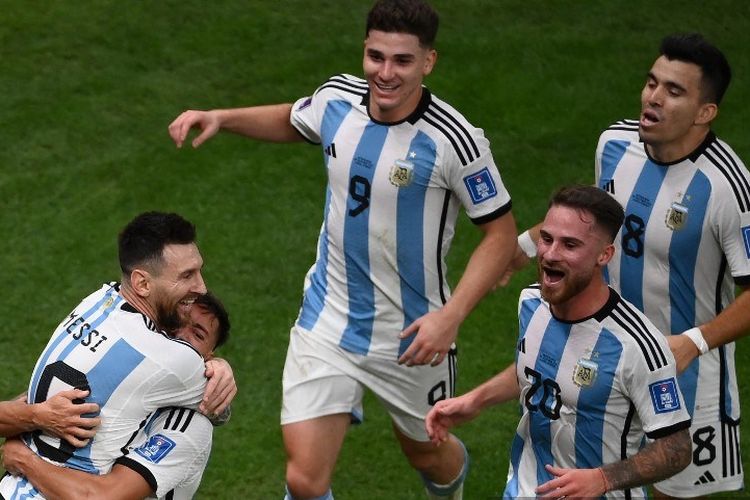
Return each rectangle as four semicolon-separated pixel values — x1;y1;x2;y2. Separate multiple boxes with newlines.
116;408;213;500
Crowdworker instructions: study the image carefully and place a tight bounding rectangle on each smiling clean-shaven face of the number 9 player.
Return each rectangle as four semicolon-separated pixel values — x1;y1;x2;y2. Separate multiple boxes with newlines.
362;30;437;123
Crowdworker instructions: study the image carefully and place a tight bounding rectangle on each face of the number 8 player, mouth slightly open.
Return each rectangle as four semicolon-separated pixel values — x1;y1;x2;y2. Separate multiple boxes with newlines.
638;56;717;163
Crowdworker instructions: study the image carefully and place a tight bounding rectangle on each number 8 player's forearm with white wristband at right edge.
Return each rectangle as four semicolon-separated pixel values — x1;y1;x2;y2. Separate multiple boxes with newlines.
667;287;750;372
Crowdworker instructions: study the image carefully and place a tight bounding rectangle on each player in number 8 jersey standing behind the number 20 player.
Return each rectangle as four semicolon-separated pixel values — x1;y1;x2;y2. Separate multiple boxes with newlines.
508;34;750;498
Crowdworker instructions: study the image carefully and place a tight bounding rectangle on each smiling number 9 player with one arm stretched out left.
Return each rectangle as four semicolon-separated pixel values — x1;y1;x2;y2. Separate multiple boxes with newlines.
169;0;516;499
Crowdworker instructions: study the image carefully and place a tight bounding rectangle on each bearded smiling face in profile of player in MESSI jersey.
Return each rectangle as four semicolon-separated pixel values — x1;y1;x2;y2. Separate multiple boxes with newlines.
148;243;206;330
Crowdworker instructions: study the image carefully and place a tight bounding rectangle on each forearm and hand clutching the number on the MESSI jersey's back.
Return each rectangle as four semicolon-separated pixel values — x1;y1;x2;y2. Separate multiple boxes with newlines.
0;389;100;447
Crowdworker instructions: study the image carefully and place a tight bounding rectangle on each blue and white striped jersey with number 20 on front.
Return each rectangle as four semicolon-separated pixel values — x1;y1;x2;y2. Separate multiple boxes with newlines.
504;286;690;498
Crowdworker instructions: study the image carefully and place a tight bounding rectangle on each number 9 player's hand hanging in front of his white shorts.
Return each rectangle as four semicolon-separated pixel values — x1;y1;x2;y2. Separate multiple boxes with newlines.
398;308;459;366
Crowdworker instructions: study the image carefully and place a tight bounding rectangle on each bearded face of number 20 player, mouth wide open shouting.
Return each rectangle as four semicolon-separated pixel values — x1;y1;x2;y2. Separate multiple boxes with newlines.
537;205;614;320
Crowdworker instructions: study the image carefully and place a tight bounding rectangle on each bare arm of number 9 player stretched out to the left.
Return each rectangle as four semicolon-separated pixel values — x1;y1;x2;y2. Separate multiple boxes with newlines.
169;104;303;148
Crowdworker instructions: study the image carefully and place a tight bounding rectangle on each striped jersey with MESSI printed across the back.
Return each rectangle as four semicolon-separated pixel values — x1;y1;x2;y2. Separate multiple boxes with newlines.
0;284;206;500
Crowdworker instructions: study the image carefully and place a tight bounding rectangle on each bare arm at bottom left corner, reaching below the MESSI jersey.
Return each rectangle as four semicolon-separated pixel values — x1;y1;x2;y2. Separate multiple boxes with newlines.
2;439;153;500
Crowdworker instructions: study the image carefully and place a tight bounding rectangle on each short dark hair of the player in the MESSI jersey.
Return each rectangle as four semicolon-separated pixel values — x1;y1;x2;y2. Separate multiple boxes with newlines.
117;212;195;276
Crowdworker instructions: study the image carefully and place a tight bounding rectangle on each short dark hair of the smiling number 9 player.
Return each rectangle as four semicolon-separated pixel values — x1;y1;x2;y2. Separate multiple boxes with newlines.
365;0;440;48
